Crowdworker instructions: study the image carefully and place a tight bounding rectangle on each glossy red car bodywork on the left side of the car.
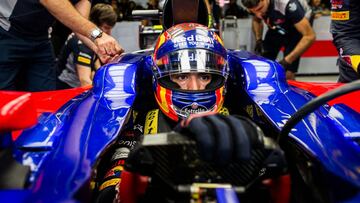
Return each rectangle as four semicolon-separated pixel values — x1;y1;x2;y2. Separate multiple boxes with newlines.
0;86;91;139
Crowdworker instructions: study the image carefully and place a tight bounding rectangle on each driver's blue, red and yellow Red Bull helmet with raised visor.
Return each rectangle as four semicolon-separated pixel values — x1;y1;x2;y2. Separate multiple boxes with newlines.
153;23;229;121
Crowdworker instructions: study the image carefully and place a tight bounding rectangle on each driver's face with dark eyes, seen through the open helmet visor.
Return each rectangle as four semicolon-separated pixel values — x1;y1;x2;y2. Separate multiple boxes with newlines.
170;73;211;90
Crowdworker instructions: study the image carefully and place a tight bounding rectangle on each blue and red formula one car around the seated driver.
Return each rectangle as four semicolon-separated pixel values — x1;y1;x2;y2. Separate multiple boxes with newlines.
0;0;360;202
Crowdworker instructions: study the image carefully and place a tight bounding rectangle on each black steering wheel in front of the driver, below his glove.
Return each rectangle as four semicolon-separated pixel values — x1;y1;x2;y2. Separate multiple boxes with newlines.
120;132;286;202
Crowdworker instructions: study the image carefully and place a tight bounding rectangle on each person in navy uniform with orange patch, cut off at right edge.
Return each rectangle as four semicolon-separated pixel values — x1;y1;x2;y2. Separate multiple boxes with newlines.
330;0;360;83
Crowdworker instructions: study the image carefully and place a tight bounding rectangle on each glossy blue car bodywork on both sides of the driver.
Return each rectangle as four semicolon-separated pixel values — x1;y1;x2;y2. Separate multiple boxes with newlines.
0;50;360;202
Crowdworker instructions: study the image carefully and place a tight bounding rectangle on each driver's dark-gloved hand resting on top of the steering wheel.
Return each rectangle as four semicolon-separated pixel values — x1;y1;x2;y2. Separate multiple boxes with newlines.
175;114;263;164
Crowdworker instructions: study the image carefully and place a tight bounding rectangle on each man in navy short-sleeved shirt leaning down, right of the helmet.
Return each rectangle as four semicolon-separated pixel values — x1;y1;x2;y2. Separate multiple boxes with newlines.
242;0;315;80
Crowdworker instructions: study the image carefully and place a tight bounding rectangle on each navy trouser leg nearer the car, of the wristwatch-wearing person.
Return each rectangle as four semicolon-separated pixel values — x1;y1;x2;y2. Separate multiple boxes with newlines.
26;41;56;92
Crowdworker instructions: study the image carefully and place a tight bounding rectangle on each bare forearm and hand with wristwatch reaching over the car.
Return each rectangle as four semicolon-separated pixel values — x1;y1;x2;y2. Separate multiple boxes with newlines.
40;0;123;62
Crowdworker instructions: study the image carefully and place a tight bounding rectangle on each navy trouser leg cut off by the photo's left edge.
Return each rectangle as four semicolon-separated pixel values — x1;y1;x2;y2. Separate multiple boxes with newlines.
0;27;22;90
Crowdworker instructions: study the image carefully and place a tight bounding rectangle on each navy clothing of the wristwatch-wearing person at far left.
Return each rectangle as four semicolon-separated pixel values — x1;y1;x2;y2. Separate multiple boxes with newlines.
0;0;79;91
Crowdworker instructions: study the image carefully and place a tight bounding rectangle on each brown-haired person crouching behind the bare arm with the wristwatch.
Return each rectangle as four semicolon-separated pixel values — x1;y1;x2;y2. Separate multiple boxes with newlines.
56;3;117;89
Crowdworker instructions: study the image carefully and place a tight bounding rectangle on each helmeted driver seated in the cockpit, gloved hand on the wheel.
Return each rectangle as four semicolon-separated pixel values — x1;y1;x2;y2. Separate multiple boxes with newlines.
93;23;268;202
